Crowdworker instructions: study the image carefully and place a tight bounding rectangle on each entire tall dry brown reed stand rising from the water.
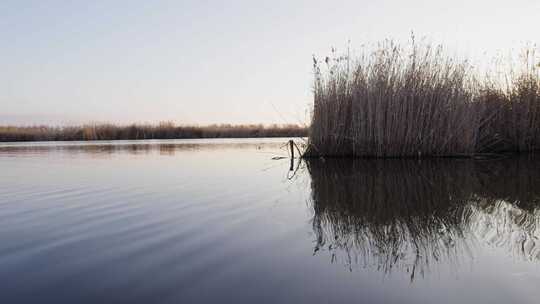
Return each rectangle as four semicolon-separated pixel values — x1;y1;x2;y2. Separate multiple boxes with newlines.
305;37;540;157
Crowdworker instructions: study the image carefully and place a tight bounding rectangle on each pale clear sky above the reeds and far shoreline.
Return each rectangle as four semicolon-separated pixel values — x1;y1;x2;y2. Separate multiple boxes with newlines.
0;0;540;124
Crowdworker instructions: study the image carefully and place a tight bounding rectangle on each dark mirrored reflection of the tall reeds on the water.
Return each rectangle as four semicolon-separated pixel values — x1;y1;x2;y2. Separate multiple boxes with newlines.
307;158;540;280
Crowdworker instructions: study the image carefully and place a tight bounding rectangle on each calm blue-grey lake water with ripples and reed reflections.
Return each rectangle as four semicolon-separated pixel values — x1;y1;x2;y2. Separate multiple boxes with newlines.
0;139;540;303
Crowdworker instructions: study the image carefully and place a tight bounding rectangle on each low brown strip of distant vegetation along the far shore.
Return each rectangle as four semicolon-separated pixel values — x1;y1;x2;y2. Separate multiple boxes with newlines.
0;122;307;142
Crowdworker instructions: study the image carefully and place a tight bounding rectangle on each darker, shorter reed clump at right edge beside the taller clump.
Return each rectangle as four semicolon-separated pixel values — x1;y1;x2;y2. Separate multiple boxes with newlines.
477;48;540;152
